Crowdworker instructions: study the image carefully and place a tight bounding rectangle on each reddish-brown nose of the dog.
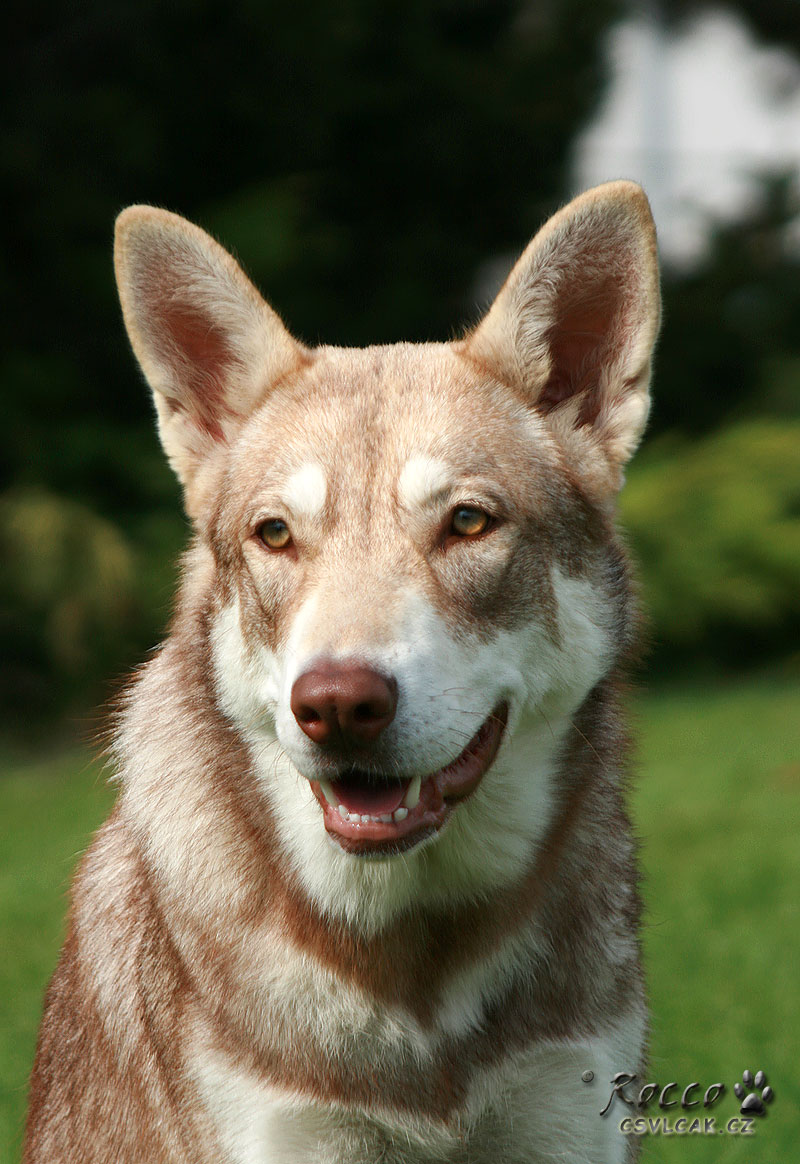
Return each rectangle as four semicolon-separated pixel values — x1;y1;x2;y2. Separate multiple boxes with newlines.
290;662;397;744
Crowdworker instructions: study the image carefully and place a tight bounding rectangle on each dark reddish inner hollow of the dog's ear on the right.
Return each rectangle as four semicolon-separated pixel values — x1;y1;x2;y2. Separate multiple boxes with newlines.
538;275;623;424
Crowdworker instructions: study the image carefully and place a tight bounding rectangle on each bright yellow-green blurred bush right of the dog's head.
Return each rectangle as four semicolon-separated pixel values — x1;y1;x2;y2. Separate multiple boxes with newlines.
621;419;800;663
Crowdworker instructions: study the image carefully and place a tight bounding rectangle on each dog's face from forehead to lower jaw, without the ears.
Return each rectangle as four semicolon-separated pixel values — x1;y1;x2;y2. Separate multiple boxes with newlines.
210;345;615;856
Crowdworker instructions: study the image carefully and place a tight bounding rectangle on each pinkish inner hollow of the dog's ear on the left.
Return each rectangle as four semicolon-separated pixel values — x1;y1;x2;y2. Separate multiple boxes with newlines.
156;301;234;440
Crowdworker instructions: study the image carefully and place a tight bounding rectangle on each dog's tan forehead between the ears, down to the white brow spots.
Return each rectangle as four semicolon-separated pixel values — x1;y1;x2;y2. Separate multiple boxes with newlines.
236;343;552;500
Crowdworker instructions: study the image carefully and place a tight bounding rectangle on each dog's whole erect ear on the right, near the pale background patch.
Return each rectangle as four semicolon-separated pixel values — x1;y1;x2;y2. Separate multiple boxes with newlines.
461;182;660;492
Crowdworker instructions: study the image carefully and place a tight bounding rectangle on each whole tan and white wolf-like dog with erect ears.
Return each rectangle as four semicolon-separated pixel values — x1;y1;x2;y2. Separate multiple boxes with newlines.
24;182;659;1164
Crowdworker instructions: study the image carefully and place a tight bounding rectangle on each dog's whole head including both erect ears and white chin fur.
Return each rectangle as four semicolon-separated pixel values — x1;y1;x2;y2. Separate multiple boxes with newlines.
118;184;658;917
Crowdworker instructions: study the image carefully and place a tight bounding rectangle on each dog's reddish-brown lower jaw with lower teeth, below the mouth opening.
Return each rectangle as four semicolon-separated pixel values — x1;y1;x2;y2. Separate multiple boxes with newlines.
311;702;509;858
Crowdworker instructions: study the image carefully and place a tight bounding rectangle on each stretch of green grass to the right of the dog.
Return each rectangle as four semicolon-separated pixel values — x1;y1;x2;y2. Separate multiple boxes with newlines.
632;680;800;1164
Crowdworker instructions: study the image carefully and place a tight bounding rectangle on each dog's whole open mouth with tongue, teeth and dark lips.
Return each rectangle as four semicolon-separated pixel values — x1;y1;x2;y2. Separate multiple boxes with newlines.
311;703;509;856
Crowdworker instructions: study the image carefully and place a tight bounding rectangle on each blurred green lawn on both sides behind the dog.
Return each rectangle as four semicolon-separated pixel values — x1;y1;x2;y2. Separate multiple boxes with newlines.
0;677;800;1164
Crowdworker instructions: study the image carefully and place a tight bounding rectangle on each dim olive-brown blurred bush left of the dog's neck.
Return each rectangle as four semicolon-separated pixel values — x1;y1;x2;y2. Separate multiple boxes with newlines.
0;487;183;728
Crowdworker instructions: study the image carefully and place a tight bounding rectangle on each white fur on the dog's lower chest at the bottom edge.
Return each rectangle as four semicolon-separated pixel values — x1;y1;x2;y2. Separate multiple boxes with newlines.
193;1015;643;1164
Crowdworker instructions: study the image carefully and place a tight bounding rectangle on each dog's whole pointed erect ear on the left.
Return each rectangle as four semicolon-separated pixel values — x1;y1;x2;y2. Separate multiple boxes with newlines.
114;206;309;488
